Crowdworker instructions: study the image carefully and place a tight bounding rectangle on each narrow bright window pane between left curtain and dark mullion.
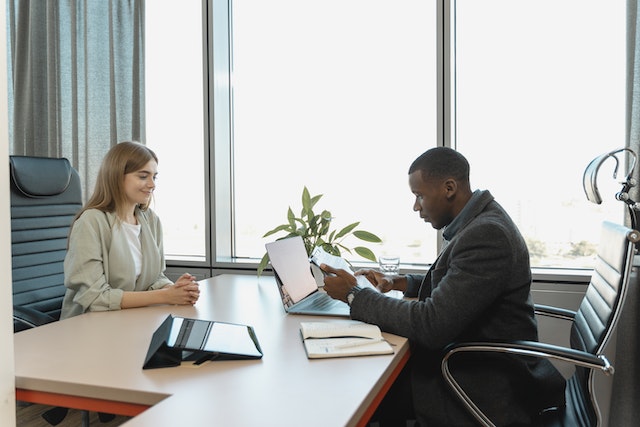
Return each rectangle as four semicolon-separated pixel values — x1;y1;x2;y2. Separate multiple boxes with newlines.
145;0;207;261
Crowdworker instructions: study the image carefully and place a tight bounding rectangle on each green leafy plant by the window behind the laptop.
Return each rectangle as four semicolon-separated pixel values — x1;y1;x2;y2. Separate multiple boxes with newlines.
258;187;382;276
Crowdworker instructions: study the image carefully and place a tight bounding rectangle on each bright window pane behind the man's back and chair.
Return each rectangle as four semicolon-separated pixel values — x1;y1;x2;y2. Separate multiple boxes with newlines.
455;0;625;268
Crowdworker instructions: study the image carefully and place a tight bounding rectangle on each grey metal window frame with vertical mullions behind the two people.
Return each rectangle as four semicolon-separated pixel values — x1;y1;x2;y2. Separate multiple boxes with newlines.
196;0;608;283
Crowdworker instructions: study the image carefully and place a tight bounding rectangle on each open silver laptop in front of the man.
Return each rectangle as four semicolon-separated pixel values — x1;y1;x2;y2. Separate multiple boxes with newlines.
265;236;349;317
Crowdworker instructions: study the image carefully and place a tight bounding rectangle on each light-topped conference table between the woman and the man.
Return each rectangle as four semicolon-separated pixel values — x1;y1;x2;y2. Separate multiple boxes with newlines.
14;274;410;427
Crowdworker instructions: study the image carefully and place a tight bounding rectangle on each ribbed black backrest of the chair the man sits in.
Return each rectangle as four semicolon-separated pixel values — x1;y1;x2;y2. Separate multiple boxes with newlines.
566;221;640;426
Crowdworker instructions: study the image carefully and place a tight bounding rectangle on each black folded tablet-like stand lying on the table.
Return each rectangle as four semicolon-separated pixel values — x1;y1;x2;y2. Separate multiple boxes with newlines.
142;315;262;369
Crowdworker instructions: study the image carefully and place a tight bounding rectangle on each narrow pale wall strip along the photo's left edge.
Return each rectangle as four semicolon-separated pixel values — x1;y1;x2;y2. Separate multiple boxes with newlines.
0;0;16;426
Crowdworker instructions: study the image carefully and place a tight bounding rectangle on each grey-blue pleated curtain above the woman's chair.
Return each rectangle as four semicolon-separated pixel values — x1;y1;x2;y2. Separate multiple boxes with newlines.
7;0;145;197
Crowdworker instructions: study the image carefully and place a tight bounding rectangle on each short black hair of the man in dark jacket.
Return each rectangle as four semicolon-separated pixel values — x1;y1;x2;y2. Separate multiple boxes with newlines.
409;147;469;182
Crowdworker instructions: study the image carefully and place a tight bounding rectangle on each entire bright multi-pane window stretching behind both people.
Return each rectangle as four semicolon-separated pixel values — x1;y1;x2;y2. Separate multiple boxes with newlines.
146;0;625;274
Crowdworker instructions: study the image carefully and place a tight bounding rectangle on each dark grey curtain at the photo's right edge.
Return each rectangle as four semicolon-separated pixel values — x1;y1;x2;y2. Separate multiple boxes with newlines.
609;0;640;427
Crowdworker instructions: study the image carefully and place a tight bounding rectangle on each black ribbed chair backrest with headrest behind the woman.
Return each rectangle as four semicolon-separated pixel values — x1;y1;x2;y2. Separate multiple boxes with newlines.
9;156;82;331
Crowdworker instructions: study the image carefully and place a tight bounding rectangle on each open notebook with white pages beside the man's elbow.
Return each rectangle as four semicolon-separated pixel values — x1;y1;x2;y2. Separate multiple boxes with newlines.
300;320;393;359
